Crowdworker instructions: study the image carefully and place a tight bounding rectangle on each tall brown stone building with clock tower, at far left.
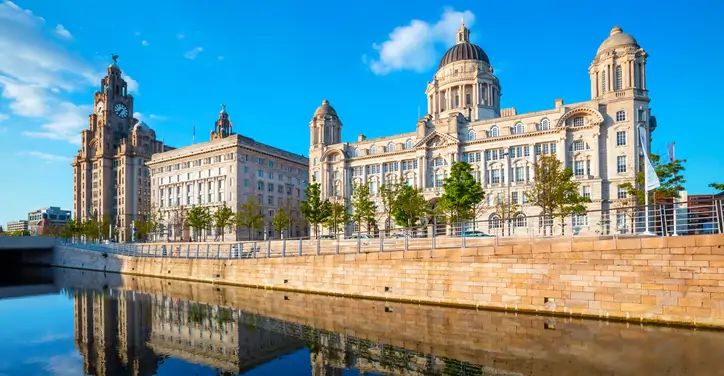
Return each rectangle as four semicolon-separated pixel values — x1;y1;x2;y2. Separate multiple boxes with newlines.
71;56;173;241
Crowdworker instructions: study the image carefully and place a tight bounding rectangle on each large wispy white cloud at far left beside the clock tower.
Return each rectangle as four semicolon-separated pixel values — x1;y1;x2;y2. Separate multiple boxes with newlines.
0;1;119;144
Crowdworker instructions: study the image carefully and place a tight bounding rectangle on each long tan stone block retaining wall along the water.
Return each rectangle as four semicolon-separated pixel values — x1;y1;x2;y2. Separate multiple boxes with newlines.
53;235;724;327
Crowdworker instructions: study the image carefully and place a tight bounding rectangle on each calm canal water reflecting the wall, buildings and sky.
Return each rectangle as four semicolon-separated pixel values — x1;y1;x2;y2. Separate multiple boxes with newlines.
0;269;724;376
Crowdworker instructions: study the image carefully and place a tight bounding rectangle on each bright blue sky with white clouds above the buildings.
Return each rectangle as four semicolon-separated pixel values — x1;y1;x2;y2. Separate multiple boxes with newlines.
0;0;724;226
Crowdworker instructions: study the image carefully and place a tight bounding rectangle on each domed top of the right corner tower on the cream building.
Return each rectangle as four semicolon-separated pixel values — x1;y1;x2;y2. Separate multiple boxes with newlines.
588;26;649;101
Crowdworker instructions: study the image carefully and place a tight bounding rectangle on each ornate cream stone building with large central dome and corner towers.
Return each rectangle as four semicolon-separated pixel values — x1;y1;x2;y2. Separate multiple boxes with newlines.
309;23;656;236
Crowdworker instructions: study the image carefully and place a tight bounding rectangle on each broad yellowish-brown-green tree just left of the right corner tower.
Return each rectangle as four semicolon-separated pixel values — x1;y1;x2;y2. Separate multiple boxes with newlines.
527;155;590;234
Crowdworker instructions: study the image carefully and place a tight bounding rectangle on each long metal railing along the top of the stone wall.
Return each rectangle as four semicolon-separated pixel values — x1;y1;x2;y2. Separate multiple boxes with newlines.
62;201;724;259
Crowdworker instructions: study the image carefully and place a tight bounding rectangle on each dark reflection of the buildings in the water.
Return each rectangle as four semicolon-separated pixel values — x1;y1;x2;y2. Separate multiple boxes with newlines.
70;290;504;376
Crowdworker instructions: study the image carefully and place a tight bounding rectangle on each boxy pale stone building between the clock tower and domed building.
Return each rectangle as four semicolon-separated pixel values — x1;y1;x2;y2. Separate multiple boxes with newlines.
148;106;309;240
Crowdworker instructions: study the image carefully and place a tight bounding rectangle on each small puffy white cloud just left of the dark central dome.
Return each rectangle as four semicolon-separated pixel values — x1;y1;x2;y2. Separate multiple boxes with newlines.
363;8;475;75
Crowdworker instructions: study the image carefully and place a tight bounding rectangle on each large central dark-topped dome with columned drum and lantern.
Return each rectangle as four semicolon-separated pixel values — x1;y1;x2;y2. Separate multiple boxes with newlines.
425;22;501;122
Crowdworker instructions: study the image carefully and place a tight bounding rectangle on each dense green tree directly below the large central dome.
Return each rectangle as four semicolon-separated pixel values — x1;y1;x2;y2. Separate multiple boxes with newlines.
440;161;485;226
